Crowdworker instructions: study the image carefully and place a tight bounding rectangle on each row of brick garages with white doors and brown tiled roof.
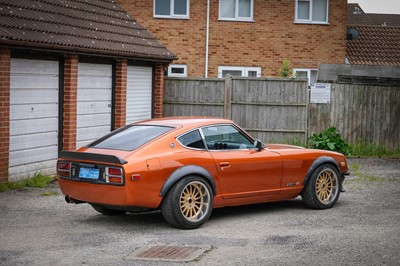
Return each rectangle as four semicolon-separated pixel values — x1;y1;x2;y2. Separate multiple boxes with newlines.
0;0;176;182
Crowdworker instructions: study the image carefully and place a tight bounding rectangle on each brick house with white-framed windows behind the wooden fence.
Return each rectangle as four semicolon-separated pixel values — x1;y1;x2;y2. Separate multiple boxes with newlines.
117;0;347;81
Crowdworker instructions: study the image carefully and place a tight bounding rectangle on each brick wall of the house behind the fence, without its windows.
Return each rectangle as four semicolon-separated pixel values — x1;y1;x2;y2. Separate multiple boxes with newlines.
118;0;347;77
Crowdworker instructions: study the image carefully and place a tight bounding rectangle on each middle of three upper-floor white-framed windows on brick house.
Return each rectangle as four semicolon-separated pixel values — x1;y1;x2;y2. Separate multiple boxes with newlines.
219;0;253;21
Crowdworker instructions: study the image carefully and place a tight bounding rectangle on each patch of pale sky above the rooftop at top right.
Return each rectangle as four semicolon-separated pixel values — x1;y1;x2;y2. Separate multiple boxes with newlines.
347;0;400;14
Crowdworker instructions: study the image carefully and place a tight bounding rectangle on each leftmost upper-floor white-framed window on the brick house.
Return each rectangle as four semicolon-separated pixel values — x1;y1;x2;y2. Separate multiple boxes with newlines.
154;0;190;18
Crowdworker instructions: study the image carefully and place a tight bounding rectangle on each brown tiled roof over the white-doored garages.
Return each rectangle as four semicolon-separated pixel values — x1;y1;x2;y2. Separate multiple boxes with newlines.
0;0;176;61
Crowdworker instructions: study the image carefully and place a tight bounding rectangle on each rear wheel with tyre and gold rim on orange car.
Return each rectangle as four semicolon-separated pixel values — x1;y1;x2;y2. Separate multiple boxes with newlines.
161;176;214;229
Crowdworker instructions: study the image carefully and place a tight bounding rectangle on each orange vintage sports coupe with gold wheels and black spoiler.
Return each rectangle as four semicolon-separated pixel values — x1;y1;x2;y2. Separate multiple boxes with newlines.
57;117;348;229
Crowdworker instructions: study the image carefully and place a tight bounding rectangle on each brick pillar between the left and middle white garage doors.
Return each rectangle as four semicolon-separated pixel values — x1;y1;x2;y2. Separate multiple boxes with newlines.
62;54;78;150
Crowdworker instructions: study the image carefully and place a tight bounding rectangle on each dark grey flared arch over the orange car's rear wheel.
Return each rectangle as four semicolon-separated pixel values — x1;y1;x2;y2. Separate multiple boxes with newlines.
160;165;217;196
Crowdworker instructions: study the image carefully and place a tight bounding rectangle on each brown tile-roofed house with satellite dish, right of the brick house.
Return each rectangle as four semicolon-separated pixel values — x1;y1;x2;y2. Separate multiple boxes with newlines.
346;4;400;66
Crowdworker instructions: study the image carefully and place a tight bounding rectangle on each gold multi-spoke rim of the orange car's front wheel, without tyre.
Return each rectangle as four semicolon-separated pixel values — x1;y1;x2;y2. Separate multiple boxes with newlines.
315;168;338;204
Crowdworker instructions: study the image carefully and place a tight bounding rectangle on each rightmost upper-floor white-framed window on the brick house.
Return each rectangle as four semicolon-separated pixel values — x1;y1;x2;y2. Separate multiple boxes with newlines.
296;0;329;23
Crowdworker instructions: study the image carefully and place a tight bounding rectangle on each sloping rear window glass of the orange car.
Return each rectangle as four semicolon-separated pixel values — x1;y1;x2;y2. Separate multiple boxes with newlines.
89;125;173;151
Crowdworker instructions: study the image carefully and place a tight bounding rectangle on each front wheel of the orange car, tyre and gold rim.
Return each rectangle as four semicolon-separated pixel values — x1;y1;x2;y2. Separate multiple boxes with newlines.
301;164;340;209
